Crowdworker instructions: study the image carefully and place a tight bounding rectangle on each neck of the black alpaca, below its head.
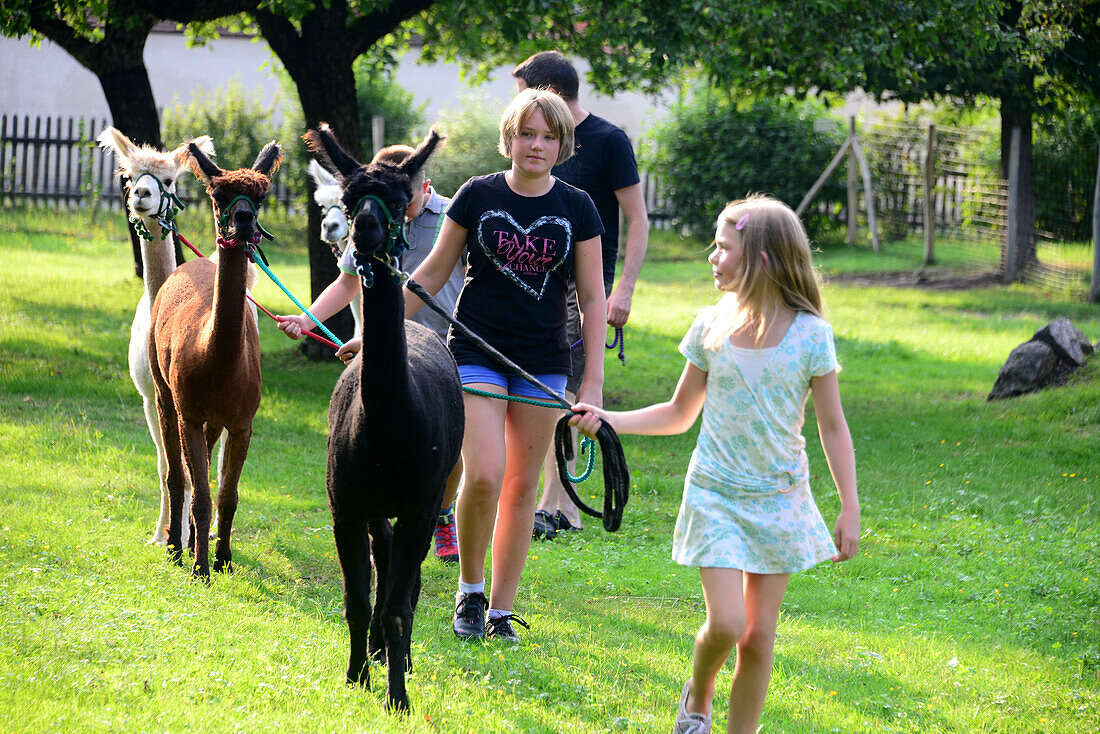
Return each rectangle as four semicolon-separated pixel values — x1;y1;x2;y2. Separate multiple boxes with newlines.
360;264;408;396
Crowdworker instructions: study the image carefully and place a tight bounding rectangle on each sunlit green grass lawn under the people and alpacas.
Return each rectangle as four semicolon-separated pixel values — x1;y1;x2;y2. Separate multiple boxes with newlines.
0;210;1100;734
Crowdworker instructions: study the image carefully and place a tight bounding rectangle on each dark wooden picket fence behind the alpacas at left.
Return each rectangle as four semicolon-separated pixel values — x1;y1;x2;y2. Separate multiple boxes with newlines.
0;114;305;209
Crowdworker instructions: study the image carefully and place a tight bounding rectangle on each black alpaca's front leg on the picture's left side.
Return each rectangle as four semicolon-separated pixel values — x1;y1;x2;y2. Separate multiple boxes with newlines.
332;522;371;690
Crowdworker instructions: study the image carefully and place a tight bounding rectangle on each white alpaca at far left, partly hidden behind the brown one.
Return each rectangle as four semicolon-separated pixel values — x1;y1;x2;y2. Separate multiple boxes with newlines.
98;127;221;546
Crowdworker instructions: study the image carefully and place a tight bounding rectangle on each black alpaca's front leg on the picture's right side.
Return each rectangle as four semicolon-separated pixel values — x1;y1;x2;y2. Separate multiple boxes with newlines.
383;513;438;711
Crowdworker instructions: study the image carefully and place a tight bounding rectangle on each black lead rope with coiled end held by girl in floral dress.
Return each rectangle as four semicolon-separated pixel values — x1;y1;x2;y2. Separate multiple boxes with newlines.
403;274;630;533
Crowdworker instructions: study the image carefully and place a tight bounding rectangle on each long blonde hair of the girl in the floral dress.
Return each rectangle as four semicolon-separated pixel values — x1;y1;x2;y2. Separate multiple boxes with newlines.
703;194;823;350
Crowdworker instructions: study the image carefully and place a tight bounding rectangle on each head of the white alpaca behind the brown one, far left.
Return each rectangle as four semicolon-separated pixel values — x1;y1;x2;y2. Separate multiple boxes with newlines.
97;127;213;227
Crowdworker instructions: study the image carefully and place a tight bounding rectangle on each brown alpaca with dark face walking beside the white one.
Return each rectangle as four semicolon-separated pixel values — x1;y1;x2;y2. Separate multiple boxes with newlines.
149;141;283;579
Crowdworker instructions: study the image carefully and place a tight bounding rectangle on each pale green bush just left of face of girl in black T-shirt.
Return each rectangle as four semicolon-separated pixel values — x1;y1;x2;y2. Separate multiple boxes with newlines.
428;96;509;196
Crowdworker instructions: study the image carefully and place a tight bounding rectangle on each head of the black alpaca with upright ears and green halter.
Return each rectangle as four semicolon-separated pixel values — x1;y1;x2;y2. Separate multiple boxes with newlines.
304;122;442;268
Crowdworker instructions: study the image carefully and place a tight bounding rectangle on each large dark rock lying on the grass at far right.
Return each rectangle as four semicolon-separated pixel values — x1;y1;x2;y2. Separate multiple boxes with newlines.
988;318;1100;401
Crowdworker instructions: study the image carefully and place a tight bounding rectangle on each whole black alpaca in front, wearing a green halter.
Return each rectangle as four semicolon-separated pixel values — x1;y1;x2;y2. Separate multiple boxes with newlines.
305;123;465;711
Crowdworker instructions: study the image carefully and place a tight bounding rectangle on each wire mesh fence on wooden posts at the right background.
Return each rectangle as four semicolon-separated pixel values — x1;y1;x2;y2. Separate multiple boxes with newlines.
862;117;1097;294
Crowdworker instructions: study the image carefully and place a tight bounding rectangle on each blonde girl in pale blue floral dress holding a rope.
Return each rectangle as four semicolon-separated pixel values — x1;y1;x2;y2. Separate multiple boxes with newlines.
572;196;859;734
